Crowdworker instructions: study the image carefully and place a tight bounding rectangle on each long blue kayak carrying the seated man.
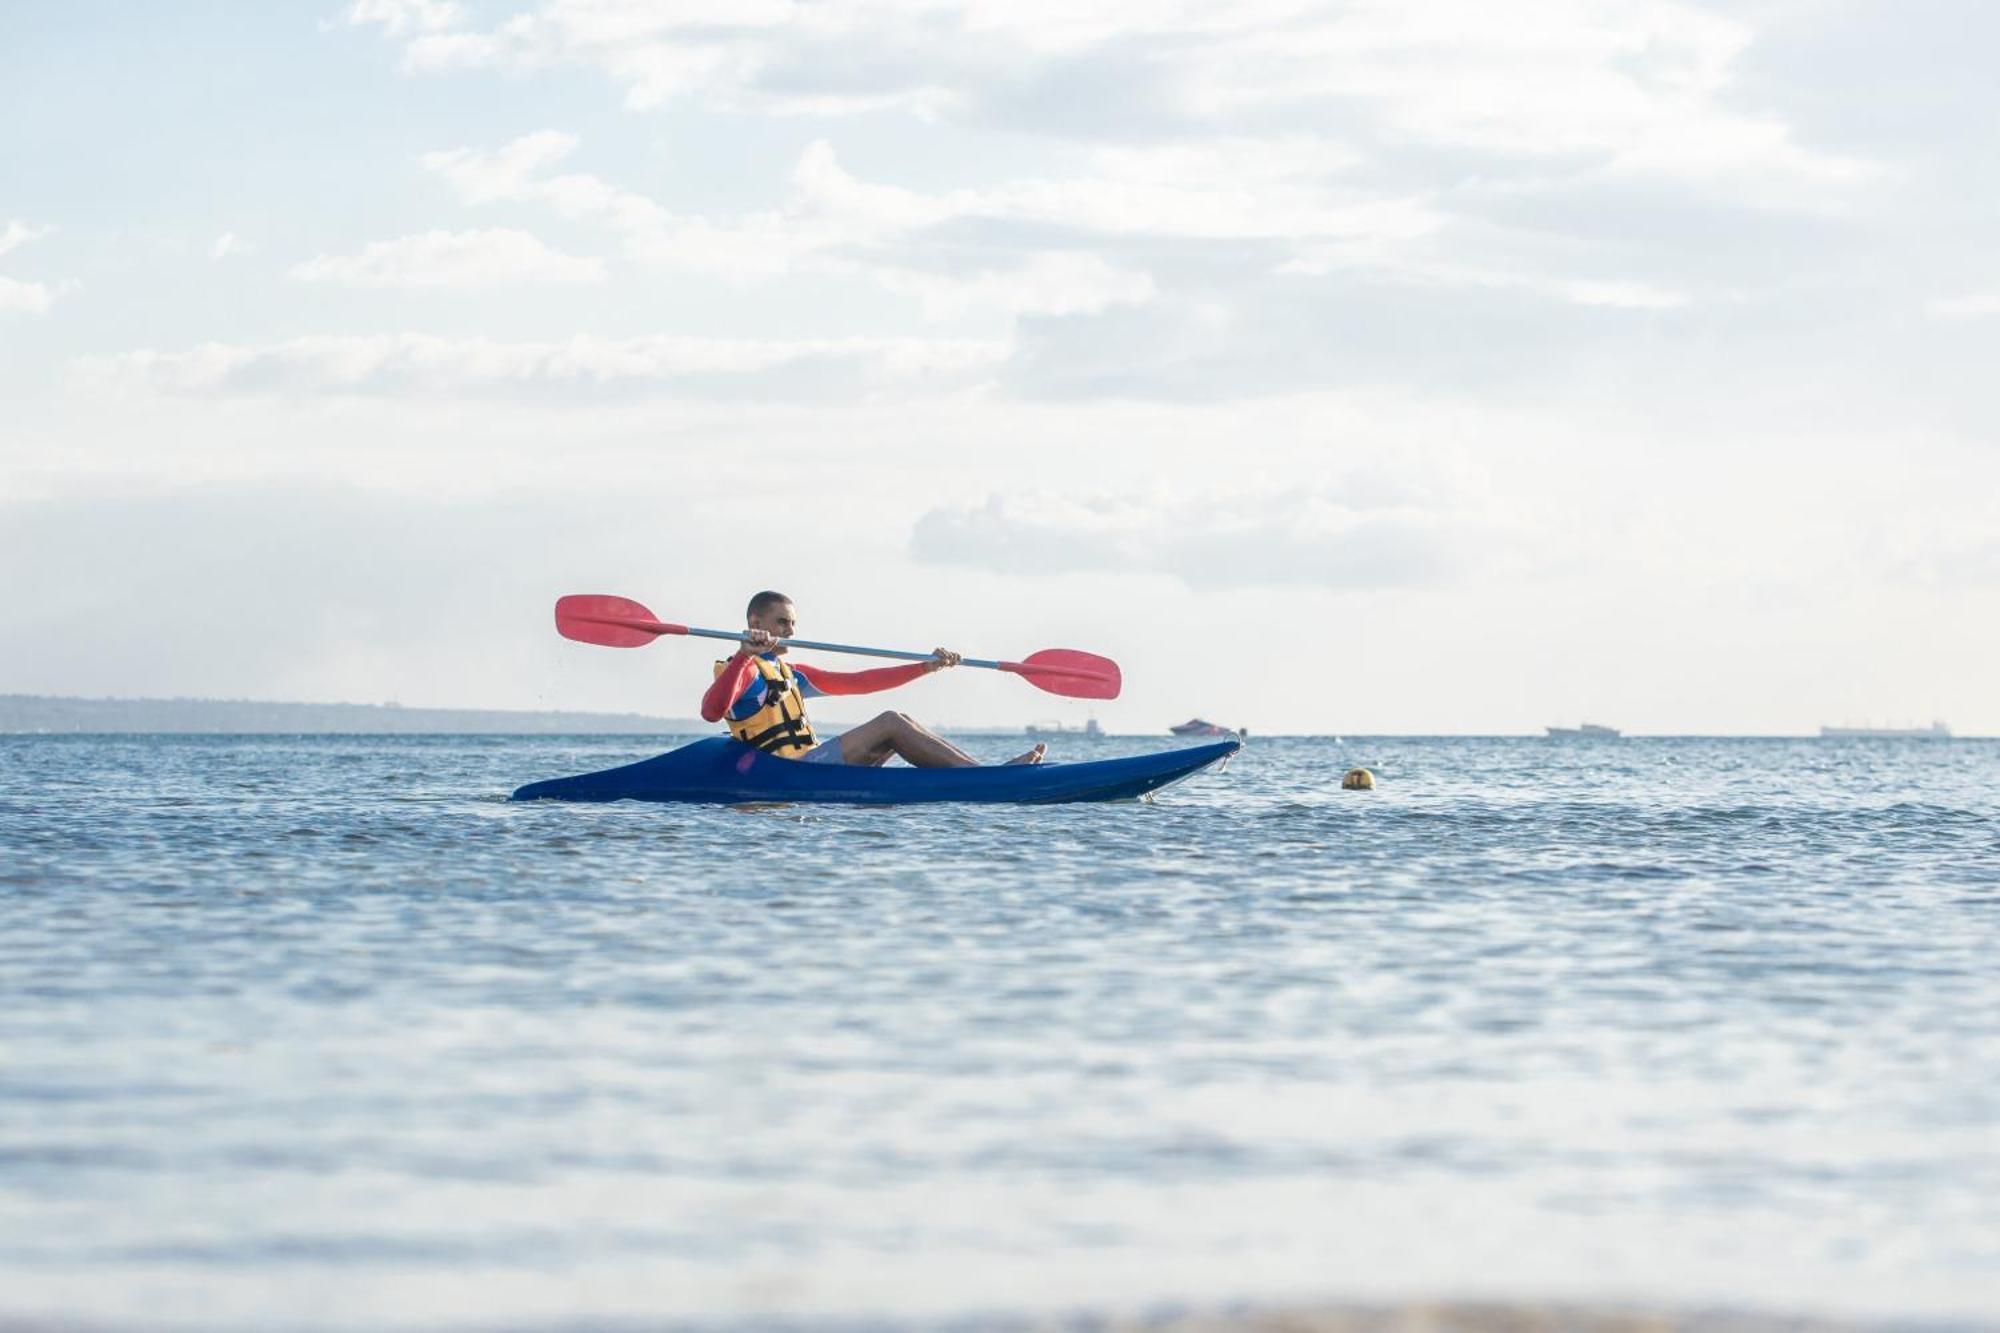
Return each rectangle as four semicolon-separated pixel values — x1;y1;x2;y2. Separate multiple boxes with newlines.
514;737;1242;805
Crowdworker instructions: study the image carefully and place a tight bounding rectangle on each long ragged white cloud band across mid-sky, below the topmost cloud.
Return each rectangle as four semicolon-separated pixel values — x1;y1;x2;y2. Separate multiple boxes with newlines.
424;130;1736;318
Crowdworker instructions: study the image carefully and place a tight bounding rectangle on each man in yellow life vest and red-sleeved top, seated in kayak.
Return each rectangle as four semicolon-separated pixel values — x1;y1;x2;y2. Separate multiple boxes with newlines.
702;592;1048;769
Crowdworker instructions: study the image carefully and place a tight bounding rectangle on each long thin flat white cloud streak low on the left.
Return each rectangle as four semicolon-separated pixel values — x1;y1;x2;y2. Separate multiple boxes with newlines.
74;334;1006;398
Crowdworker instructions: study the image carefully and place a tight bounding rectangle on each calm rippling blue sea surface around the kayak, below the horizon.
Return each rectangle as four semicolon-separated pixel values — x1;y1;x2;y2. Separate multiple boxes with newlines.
0;737;2000;1329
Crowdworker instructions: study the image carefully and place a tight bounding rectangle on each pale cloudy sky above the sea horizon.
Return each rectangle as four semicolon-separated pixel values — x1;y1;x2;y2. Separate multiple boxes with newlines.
0;0;2000;735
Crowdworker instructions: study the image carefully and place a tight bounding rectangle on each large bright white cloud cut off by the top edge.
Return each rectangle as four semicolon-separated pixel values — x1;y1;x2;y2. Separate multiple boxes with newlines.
372;0;1862;197
